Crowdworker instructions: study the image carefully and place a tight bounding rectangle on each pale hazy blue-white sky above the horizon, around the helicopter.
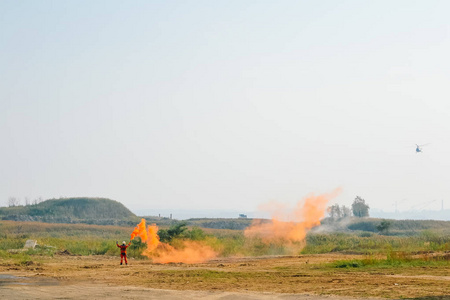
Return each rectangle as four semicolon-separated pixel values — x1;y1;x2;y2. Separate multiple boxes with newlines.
0;0;450;213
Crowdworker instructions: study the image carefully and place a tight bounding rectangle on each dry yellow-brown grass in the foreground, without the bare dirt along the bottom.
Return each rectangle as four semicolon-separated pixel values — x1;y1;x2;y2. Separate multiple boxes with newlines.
0;254;450;299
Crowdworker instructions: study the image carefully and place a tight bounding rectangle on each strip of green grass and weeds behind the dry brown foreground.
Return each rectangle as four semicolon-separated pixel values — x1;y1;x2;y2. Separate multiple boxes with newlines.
0;221;450;259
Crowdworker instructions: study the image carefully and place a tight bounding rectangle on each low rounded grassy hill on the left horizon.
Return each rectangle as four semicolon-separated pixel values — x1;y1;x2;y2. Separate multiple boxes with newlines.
0;198;138;225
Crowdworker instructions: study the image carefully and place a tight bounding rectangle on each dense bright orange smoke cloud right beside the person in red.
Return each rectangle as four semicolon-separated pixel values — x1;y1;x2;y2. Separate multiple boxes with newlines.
131;219;217;264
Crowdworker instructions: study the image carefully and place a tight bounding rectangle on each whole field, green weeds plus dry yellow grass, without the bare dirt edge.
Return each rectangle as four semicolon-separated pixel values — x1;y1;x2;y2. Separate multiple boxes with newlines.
0;221;450;299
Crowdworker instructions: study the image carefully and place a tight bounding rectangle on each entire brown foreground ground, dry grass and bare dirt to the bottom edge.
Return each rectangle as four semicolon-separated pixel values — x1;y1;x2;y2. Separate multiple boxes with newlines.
0;254;450;300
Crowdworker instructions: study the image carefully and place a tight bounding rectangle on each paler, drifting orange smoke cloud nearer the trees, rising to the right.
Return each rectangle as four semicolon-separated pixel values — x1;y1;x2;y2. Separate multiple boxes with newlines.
245;189;341;242
